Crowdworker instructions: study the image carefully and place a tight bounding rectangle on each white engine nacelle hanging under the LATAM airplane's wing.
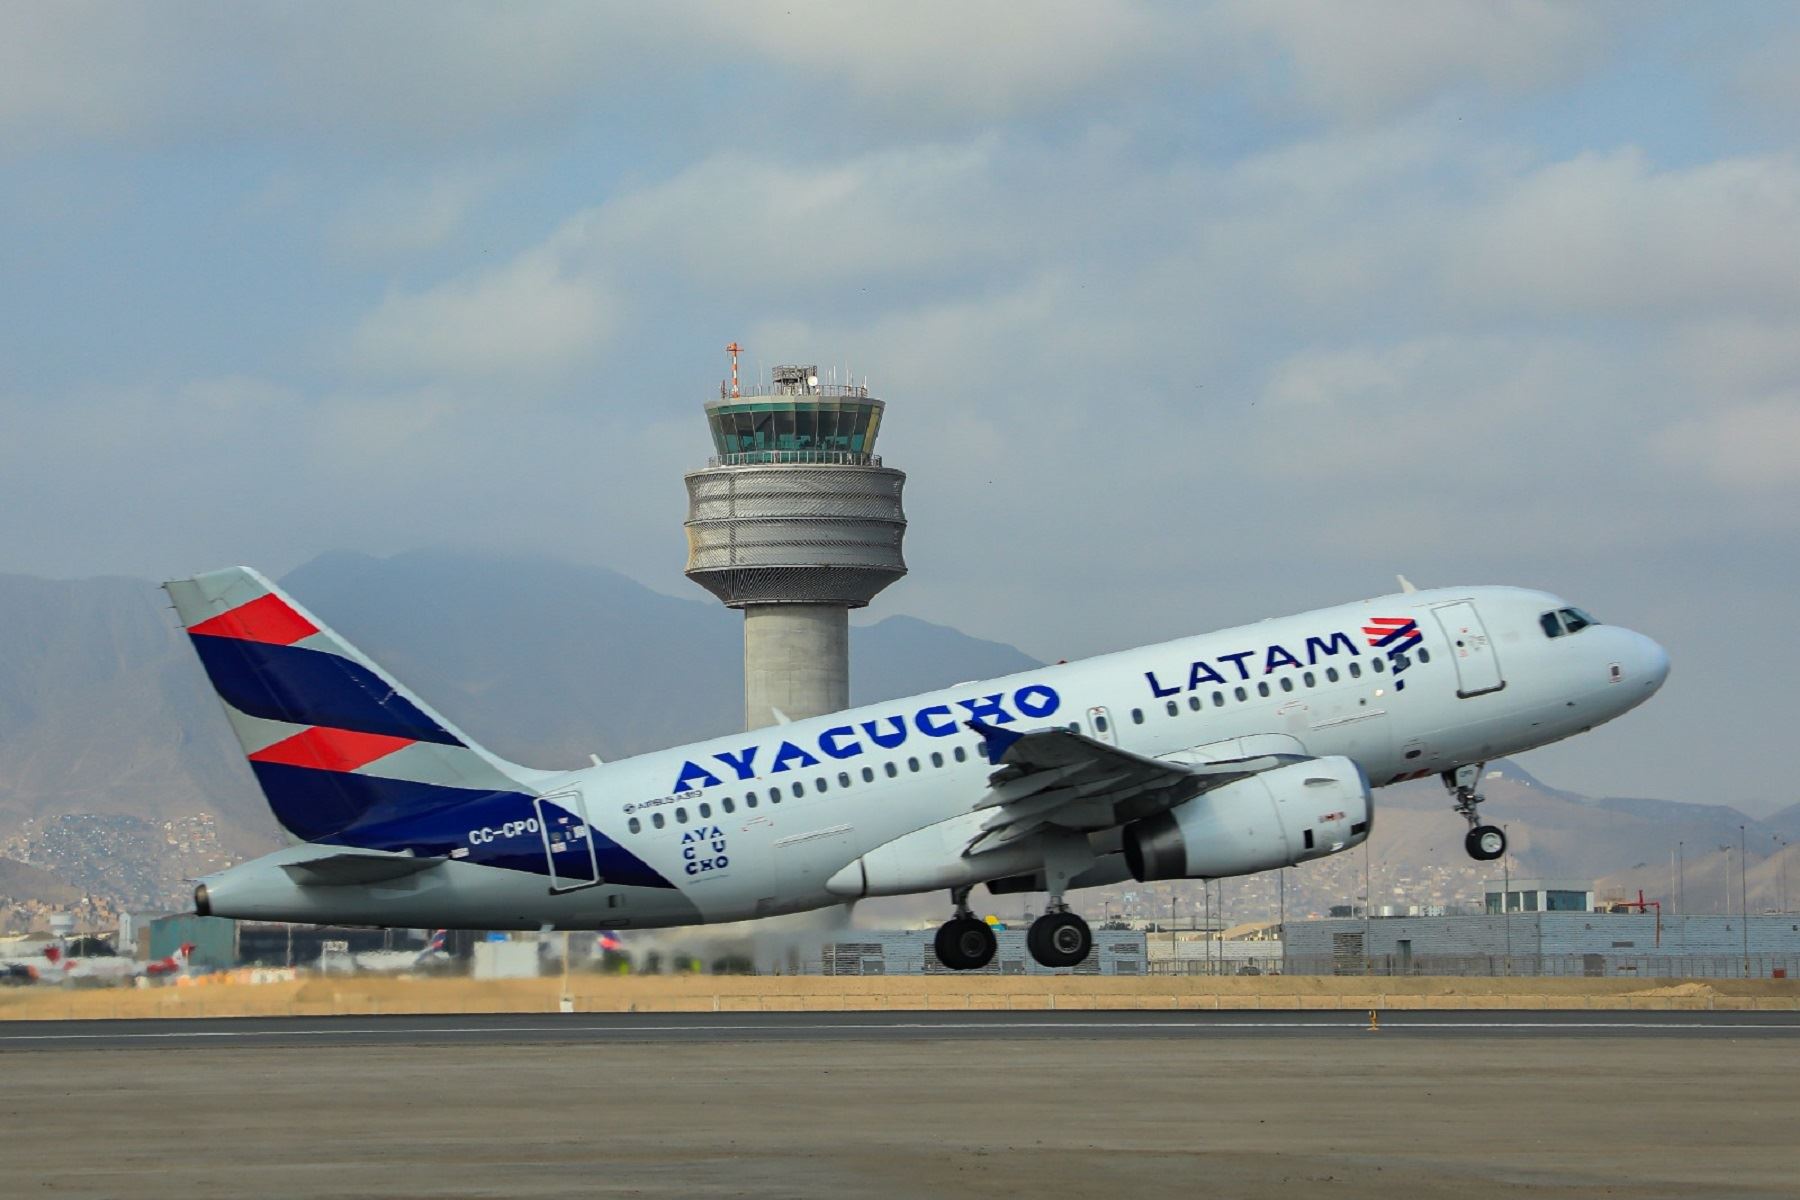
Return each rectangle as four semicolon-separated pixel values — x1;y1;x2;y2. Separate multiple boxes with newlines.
1125;757;1372;882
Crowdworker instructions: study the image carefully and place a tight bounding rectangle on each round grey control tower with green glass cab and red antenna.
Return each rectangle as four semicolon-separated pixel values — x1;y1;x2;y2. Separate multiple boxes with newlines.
686;354;905;729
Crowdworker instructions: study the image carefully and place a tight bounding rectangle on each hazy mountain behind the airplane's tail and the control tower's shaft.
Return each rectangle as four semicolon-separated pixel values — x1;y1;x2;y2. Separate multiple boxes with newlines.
0;549;1035;905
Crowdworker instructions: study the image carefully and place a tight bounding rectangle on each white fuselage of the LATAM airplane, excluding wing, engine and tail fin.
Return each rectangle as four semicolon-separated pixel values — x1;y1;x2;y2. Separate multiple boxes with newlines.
209;587;1669;928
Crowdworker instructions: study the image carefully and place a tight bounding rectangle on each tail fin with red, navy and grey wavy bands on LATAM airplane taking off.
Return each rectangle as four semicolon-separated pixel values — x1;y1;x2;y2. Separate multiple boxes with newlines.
162;567;540;842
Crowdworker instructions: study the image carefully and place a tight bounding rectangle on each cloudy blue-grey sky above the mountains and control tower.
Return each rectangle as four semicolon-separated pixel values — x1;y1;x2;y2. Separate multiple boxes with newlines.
0;0;1800;811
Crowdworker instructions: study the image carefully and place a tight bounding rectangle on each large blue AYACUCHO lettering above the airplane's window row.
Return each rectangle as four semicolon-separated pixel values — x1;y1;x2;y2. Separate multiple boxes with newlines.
676;684;1062;808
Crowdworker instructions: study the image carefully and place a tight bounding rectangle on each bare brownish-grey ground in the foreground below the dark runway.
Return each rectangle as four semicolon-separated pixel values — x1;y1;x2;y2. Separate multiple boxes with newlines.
0;1034;1800;1200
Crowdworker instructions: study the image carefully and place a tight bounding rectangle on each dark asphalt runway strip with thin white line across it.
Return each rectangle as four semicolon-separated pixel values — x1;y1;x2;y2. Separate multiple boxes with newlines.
0;1011;1800;1052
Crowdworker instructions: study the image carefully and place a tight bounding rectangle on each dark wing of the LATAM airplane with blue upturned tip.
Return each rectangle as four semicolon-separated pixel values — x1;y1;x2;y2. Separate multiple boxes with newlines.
967;721;1307;855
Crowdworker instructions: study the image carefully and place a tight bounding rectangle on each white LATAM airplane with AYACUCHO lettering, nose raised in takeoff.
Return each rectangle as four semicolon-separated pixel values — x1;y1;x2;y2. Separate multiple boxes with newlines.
164;567;1669;970
